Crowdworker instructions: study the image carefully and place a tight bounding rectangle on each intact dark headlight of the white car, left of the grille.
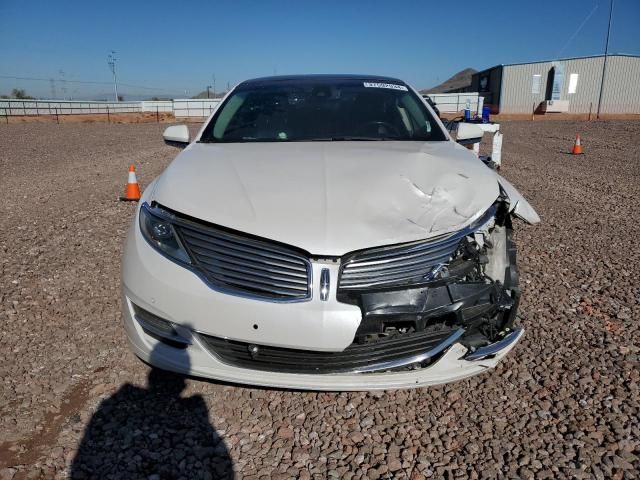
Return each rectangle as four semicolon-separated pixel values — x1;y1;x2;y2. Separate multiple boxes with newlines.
140;202;191;263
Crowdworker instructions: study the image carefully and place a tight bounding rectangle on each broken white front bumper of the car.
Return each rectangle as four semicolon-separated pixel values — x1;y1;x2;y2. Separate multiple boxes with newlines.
122;206;523;391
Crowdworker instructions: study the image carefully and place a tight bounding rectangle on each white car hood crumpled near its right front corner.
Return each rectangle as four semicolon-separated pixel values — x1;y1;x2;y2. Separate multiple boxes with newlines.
150;141;500;256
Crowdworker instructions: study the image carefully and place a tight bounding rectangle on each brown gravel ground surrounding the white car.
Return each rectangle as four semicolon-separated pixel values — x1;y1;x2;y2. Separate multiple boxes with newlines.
0;121;640;480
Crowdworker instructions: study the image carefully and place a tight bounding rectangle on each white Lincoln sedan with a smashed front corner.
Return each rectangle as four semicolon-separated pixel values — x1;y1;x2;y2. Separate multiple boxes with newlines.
123;75;539;390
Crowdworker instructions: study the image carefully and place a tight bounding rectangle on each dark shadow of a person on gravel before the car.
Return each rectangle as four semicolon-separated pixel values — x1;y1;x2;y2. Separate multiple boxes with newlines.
70;344;234;480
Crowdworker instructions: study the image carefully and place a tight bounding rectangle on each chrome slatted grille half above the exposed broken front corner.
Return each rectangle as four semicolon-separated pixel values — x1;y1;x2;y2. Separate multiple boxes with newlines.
338;207;495;291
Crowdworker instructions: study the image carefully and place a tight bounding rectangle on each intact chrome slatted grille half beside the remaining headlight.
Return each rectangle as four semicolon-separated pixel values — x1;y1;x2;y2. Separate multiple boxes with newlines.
174;219;311;301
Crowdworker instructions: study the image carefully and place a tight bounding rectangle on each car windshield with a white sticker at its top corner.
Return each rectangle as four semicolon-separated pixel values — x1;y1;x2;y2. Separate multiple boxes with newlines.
201;79;446;142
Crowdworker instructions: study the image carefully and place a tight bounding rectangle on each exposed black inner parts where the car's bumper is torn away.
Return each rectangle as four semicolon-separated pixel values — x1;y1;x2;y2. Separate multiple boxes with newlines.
338;202;520;349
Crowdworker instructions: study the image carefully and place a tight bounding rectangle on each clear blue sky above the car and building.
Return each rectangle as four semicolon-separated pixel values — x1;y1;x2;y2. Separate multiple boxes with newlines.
0;0;640;98
